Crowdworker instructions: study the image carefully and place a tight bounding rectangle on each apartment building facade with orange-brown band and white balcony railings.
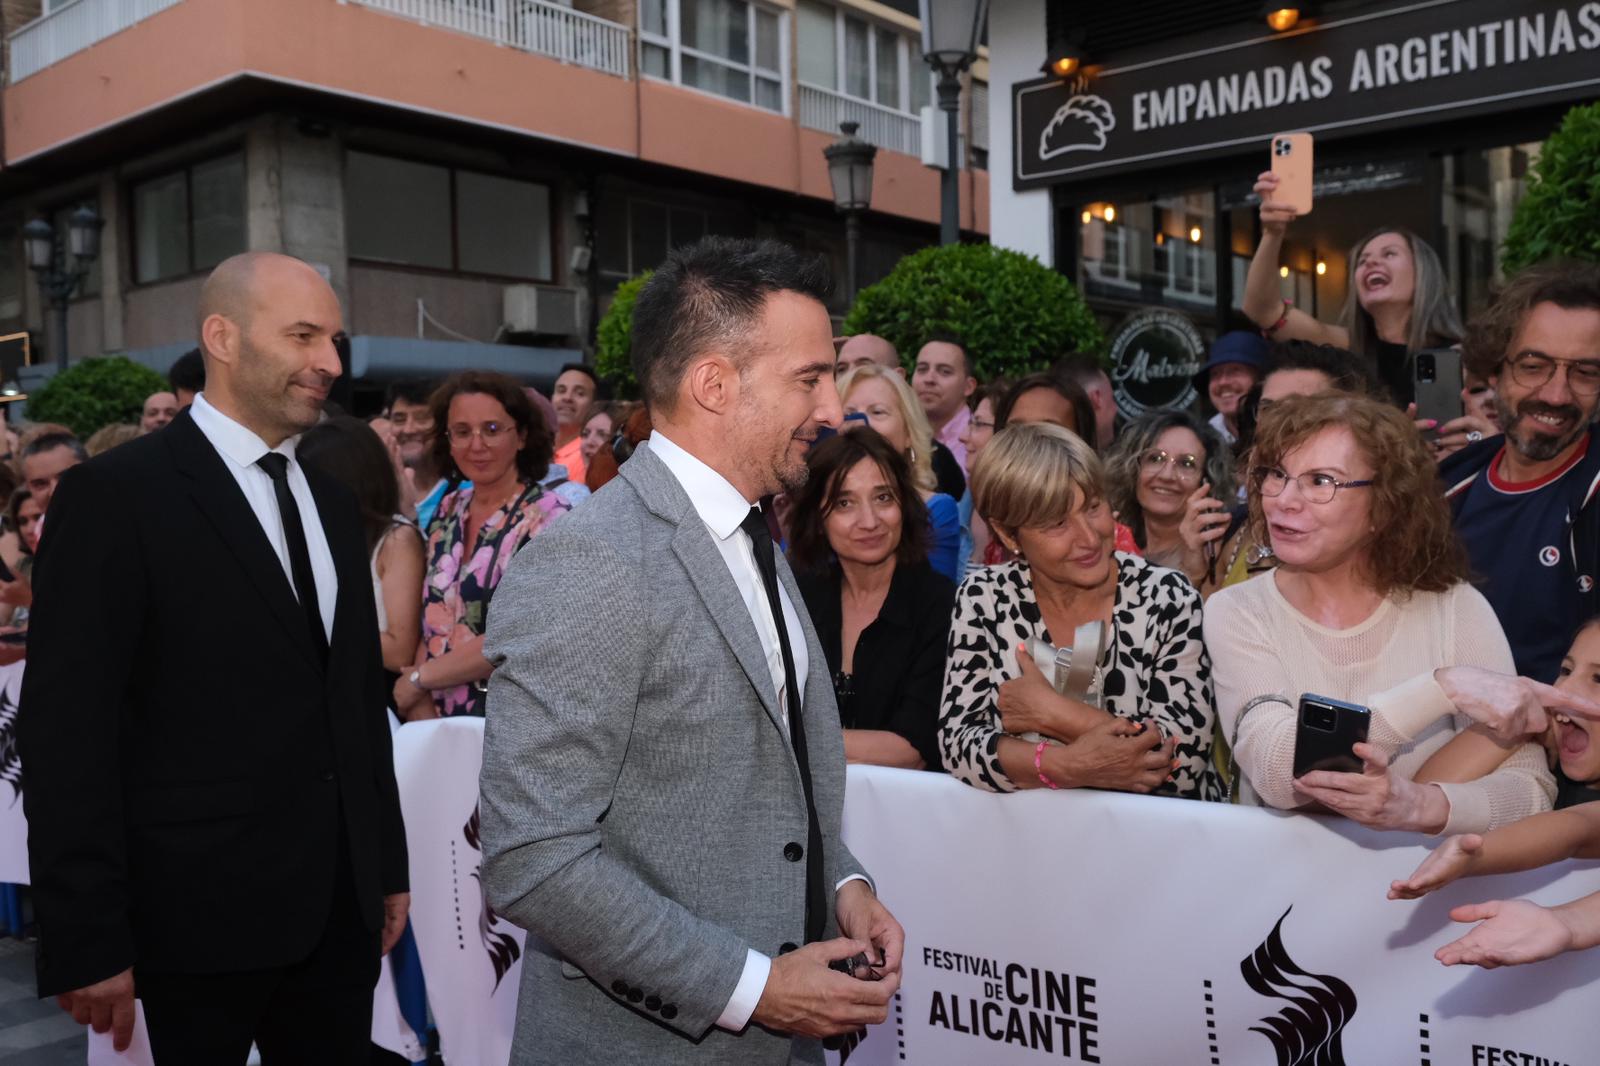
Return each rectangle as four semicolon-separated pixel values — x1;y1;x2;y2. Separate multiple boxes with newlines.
0;0;989;396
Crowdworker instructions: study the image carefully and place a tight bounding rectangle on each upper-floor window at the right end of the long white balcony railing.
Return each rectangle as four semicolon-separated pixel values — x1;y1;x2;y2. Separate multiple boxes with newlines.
638;0;789;114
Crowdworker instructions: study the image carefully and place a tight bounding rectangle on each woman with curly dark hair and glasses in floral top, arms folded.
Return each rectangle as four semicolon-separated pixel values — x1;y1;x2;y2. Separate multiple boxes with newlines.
394;370;568;720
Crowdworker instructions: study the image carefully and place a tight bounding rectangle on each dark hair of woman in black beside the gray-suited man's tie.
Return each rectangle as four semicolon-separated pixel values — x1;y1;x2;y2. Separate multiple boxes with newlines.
789;426;928;570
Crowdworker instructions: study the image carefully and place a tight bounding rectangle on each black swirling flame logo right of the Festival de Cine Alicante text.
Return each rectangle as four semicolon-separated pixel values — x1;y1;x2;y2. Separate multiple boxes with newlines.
1238;906;1355;1066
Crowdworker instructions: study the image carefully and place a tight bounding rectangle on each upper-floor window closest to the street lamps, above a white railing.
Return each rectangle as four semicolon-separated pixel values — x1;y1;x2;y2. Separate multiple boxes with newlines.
795;0;933;114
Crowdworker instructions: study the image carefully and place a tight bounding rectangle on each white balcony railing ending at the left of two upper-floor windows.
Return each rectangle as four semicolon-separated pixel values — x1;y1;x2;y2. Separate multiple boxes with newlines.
354;0;632;78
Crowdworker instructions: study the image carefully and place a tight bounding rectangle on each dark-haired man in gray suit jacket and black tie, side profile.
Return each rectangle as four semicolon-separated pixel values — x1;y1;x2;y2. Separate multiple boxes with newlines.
482;238;904;1066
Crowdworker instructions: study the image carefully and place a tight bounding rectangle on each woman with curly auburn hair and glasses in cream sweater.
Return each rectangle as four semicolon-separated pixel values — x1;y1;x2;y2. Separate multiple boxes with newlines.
1205;394;1555;832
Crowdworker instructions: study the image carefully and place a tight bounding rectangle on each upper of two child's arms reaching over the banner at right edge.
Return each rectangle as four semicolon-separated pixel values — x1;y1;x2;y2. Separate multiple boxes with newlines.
1389;804;1600;900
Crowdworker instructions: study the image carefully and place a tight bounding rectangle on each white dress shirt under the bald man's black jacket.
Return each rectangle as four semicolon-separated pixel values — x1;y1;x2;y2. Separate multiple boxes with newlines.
189;392;339;640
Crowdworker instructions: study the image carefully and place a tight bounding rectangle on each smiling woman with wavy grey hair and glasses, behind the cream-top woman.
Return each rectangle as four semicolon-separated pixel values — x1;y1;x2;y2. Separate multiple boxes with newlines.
1106;404;1235;584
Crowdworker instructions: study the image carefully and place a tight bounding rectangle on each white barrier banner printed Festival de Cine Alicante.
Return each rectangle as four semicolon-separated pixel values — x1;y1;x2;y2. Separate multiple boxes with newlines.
829;767;1600;1066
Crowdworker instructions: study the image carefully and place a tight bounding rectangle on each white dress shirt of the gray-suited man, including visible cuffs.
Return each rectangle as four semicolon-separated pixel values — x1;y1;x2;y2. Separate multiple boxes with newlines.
648;429;866;1032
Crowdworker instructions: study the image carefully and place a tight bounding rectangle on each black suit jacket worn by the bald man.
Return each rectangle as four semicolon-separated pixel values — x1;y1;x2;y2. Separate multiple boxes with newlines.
18;411;406;996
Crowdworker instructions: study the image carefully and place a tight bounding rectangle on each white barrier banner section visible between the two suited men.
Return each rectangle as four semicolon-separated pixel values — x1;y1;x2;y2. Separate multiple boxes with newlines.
394;717;523;1066
